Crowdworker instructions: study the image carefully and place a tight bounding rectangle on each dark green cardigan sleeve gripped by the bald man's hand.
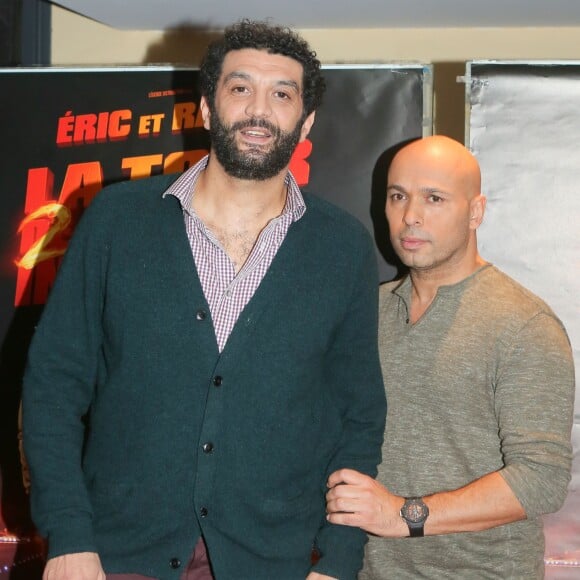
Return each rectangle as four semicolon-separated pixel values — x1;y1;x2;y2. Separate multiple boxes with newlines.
313;231;386;580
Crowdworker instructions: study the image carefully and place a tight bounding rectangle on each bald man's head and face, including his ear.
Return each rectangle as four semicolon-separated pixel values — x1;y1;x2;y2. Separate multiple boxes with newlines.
386;142;485;270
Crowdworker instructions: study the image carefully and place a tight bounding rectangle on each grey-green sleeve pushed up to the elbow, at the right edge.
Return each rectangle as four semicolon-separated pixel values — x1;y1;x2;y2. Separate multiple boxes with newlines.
496;312;575;518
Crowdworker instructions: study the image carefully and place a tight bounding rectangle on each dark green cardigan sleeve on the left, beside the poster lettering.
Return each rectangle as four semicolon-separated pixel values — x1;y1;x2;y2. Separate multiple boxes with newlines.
23;191;111;557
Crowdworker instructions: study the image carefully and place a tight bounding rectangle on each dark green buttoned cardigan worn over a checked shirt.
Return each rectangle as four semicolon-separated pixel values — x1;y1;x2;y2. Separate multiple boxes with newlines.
24;176;386;580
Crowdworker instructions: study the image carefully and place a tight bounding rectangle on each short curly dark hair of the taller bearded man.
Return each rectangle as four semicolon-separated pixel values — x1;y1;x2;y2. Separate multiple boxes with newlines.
200;19;326;118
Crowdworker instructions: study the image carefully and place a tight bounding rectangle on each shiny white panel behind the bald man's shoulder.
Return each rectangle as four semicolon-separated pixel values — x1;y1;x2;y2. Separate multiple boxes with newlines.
466;62;580;578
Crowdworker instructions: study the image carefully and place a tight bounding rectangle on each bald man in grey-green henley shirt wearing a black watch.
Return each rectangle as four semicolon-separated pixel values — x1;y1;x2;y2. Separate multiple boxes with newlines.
327;136;574;580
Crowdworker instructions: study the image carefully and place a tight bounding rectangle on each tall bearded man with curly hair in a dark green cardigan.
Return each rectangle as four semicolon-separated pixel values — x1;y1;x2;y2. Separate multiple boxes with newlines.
23;21;386;580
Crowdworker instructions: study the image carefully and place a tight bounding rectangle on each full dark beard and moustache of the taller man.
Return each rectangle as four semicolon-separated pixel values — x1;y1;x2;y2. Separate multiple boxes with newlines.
209;109;302;181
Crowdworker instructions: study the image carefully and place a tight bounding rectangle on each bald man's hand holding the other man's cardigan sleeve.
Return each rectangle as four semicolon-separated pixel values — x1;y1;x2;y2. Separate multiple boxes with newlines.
326;469;409;538
